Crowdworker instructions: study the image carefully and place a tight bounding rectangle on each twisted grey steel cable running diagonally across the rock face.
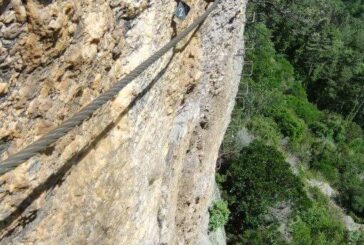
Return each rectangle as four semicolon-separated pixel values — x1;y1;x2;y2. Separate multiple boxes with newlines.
0;0;220;176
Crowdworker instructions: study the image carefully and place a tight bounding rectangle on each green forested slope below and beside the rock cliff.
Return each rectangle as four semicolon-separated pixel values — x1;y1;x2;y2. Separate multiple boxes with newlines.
210;0;364;245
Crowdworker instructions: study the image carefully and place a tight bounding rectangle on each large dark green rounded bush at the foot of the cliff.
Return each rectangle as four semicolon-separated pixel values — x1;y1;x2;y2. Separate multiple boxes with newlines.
223;141;309;235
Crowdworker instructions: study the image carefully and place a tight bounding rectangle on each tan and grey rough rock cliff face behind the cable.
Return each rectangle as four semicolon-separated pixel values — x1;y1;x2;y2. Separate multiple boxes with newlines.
0;0;246;244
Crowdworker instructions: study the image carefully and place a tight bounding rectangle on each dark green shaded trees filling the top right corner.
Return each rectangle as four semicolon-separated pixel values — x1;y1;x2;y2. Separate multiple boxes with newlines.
256;0;364;127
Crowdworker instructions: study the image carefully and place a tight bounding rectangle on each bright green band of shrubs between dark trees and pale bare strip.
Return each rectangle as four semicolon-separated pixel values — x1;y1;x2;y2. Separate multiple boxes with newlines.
243;24;364;221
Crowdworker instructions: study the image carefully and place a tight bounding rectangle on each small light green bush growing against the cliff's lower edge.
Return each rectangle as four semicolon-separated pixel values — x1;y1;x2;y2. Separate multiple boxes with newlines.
209;201;230;231
